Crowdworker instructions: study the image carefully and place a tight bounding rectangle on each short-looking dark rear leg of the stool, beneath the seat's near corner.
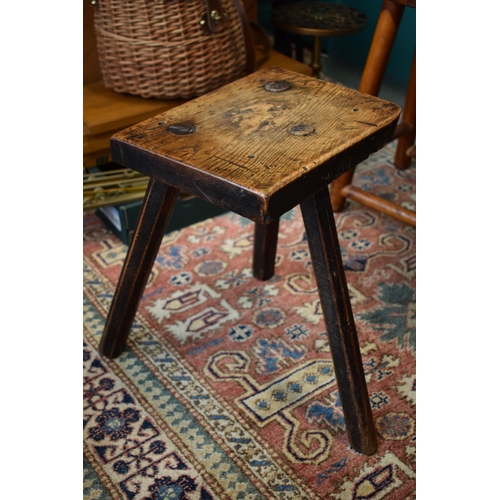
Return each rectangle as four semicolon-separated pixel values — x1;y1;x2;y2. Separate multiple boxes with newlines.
252;219;280;281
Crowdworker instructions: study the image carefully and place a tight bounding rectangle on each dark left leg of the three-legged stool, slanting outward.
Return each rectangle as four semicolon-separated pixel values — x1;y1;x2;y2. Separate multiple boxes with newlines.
99;179;179;358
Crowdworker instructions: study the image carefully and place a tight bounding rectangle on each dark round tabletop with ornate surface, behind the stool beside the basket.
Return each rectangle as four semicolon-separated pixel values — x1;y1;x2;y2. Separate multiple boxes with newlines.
271;2;367;36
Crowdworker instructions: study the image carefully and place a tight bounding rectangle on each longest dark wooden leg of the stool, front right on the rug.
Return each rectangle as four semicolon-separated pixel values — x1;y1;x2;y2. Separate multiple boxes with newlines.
300;188;377;455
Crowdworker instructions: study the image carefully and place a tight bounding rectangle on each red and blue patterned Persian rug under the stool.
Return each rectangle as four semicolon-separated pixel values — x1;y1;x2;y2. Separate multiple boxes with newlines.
83;144;416;500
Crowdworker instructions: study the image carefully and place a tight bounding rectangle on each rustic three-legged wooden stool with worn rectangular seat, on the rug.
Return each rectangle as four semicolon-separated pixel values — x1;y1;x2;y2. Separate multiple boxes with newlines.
100;68;400;454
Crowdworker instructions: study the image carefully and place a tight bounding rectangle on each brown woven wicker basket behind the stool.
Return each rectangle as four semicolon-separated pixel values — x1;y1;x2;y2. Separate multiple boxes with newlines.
94;0;250;99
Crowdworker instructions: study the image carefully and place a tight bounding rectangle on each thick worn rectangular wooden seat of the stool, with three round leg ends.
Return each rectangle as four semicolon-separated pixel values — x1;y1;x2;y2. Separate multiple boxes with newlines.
111;68;401;224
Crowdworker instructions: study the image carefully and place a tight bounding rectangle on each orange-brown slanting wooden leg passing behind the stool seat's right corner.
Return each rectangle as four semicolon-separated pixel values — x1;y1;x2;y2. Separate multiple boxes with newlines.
330;0;405;212
